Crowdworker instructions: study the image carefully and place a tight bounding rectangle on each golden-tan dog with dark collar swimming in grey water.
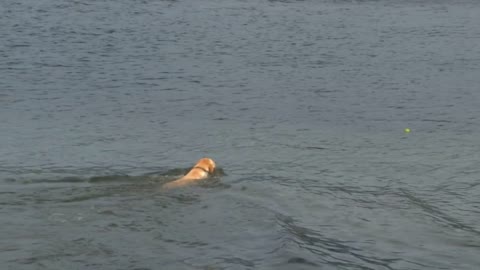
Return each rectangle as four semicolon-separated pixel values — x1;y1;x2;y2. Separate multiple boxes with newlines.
162;158;216;189
